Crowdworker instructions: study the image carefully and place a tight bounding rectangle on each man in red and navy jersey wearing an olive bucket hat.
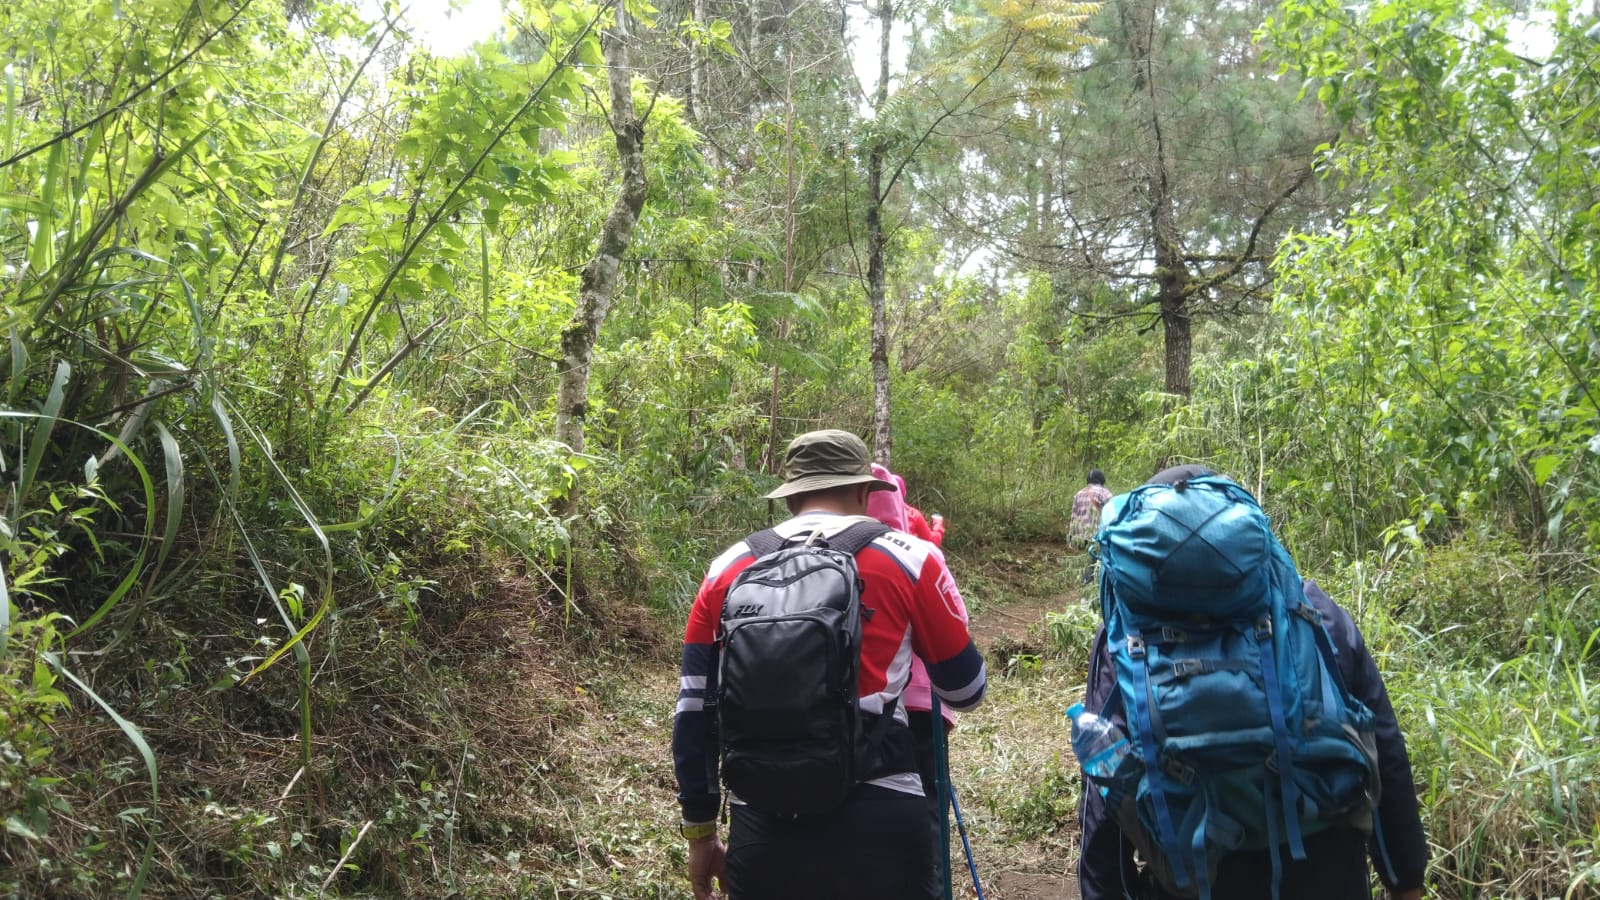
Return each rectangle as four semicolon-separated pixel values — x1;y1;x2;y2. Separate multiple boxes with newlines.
672;429;986;900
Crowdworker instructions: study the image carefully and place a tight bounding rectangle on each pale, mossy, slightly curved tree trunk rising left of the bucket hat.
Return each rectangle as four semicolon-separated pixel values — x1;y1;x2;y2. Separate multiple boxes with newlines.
555;5;645;453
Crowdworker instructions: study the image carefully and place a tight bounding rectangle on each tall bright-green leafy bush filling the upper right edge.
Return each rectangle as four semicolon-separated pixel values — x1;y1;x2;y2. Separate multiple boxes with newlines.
1267;0;1600;548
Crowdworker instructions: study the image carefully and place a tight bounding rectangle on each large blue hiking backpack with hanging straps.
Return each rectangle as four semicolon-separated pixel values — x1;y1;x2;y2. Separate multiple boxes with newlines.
1096;476;1381;900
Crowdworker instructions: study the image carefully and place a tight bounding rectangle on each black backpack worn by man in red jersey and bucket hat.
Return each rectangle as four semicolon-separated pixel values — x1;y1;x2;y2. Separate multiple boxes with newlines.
710;522;893;815
